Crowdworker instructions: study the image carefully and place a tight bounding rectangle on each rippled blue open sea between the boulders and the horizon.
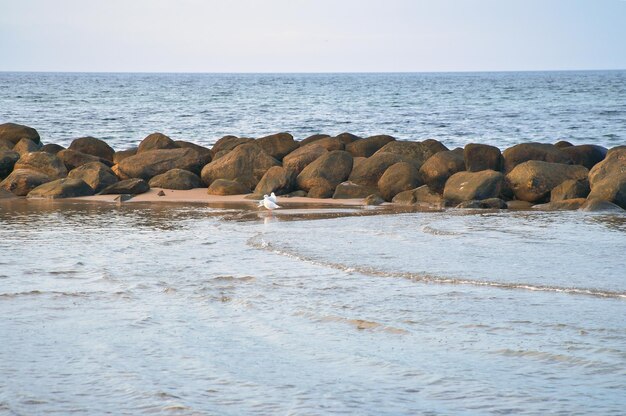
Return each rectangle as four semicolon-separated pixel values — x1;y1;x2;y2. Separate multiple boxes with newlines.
0;71;626;149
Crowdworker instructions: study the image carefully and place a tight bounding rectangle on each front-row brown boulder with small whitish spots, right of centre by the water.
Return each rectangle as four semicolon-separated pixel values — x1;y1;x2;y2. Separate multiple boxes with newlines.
443;170;504;204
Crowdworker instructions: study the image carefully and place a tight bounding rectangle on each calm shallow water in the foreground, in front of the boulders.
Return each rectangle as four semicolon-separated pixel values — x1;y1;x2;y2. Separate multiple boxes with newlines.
0;201;626;415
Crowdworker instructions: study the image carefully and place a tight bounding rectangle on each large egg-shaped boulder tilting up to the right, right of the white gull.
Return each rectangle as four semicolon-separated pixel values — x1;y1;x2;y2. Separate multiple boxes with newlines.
296;150;352;192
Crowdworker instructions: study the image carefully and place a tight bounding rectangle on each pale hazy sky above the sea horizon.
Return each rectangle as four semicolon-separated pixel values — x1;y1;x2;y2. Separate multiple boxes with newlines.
0;0;626;72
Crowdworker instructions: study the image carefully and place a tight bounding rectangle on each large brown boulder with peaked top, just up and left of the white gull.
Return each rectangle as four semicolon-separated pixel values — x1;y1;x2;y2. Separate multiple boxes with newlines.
201;143;280;190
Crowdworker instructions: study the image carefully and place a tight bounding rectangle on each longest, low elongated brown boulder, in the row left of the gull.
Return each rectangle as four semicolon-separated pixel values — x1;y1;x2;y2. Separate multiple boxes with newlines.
113;149;212;181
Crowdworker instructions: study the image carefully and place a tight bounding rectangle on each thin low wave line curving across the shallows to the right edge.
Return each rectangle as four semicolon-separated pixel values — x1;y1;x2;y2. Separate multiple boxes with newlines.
247;235;626;299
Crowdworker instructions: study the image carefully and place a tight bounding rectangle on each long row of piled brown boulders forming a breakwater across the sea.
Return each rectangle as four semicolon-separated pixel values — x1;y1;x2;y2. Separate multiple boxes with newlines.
0;123;626;211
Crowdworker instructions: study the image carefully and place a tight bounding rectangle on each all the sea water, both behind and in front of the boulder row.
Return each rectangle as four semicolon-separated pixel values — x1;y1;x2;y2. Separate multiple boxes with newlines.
0;71;626;415
